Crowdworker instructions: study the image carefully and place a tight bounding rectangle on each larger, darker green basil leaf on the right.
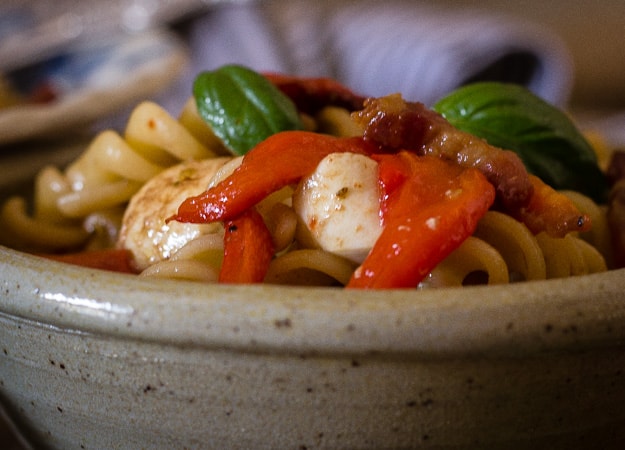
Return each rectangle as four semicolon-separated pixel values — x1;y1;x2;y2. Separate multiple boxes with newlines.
434;82;608;203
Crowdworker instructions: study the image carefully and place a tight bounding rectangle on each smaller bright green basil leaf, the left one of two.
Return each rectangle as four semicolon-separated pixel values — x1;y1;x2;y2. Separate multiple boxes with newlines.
193;65;303;155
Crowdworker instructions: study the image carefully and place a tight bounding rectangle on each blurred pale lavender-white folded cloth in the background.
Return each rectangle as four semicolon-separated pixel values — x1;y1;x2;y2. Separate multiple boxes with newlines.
169;0;573;110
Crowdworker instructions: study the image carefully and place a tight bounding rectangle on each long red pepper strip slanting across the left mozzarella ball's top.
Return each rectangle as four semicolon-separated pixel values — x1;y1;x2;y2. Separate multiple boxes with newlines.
168;131;374;223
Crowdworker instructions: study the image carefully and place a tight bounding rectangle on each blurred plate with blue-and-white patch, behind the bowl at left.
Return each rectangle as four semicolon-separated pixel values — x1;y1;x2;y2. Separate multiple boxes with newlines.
0;31;187;144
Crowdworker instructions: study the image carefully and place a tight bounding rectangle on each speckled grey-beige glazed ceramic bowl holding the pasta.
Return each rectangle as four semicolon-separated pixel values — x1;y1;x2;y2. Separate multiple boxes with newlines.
0;244;625;449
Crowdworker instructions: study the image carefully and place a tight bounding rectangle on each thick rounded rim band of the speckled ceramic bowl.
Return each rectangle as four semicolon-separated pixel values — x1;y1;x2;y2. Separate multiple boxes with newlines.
0;246;625;358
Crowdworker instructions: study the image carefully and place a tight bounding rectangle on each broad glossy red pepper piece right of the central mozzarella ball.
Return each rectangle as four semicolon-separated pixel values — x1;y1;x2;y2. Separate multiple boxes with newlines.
348;151;495;289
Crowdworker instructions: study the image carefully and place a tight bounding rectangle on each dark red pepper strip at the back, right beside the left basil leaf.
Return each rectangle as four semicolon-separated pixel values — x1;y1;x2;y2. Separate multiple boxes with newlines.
264;73;365;114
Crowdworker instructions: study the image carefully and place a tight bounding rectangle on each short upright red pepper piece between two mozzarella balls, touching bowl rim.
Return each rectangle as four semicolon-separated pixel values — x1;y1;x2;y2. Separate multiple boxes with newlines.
219;208;274;283
